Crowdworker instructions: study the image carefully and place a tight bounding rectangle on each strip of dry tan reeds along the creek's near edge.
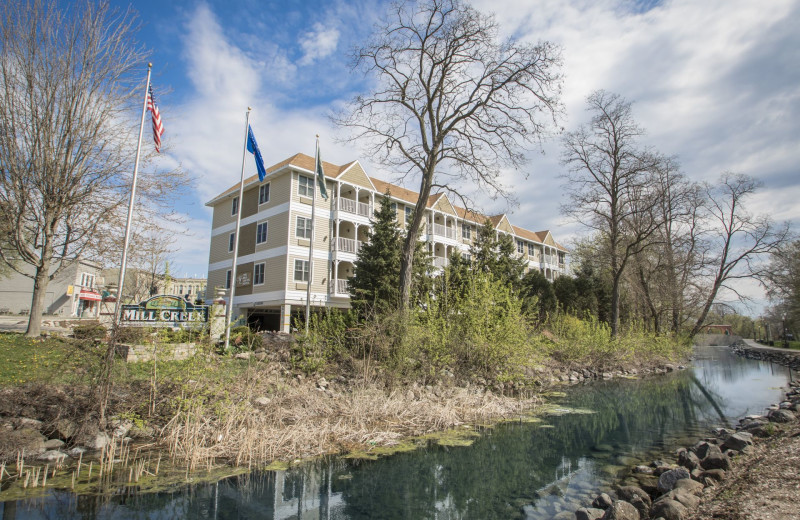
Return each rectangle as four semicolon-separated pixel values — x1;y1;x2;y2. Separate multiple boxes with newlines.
162;370;537;469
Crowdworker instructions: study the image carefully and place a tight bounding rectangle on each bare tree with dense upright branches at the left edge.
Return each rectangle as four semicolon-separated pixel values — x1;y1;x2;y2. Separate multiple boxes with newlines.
0;0;186;336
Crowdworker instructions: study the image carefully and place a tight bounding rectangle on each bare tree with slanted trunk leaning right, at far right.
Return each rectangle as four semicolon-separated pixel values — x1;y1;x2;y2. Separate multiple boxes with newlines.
690;172;789;336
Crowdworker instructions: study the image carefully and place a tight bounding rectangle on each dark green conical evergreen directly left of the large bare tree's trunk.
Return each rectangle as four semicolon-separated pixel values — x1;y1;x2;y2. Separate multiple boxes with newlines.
349;192;402;317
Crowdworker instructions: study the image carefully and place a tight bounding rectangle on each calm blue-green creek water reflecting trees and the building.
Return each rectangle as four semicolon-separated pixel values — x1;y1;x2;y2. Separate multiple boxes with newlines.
0;347;789;519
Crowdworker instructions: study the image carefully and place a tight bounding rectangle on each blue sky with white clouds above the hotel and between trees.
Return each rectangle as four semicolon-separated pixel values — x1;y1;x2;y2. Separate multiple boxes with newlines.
112;0;800;312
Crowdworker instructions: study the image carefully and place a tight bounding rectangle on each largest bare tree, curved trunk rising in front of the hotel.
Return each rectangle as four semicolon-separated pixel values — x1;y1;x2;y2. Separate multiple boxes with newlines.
334;0;561;306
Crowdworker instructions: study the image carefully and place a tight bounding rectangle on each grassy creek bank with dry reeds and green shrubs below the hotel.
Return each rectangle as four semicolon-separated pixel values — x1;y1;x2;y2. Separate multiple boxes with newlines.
0;315;688;470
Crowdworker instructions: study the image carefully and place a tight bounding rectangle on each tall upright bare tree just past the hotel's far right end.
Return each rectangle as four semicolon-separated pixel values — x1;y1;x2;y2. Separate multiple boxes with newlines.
562;90;665;336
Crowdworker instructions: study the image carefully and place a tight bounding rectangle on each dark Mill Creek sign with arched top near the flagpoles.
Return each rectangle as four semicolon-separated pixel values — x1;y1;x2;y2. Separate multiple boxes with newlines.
120;294;208;326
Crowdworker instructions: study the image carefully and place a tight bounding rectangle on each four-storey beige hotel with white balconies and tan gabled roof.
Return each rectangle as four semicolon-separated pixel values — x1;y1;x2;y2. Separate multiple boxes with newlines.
206;154;567;332
